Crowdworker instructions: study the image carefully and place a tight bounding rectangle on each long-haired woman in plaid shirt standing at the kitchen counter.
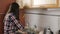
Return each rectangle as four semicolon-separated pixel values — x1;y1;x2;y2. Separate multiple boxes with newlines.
4;2;25;34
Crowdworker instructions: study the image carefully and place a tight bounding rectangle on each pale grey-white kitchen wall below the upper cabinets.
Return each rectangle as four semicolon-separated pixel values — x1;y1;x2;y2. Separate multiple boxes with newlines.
25;8;60;34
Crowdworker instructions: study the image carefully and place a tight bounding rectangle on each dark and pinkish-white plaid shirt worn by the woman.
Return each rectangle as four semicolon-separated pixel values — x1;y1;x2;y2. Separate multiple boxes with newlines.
4;13;23;34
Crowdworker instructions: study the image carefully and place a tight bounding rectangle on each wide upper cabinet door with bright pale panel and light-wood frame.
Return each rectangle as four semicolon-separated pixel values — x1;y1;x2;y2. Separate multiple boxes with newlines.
32;0;57;8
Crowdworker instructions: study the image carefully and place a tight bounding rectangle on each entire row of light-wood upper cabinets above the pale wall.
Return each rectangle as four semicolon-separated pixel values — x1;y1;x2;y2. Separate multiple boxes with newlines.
16;0;58;8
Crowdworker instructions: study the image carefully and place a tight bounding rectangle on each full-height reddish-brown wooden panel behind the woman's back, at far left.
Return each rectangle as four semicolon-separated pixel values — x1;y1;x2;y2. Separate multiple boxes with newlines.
0;0;15;34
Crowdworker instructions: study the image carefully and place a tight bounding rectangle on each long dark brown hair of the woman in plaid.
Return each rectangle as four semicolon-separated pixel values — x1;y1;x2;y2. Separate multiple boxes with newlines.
9;2;19;20
